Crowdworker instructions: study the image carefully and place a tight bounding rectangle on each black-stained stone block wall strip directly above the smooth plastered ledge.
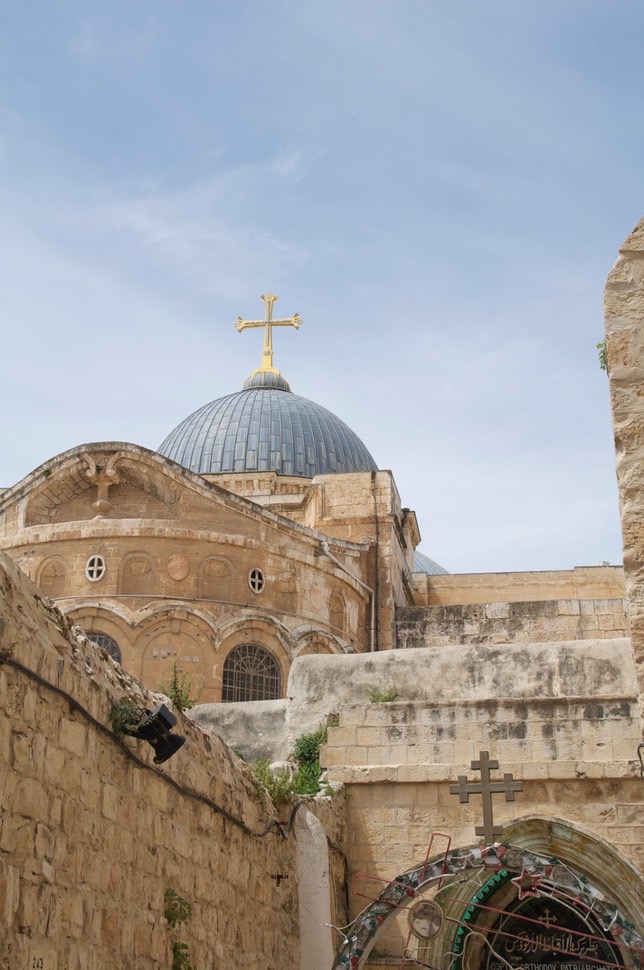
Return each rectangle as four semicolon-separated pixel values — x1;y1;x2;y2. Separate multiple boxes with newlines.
396;599;629;648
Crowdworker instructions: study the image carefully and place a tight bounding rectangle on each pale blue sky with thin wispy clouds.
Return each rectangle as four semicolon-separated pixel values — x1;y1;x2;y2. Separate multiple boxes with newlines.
0;0;644;573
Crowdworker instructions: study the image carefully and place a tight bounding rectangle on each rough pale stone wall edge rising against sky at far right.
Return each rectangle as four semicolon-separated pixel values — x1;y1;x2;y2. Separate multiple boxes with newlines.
604;219;644;726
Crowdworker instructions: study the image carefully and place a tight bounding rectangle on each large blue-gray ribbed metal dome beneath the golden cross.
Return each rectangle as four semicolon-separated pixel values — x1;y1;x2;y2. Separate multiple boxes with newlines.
158;374;378;478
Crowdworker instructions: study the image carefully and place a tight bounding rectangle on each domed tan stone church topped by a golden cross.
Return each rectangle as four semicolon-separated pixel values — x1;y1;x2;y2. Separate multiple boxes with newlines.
0;294;627;703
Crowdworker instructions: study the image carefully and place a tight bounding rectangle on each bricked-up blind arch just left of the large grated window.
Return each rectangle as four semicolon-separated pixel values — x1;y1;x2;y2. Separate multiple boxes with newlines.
134;607;218;703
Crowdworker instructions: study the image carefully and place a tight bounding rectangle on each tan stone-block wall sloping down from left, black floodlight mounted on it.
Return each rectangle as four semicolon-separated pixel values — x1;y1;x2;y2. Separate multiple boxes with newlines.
0;556;345;970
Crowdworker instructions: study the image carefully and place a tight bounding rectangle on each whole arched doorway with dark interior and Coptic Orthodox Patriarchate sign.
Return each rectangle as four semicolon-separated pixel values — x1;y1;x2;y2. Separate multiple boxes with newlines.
333;822;644;970
